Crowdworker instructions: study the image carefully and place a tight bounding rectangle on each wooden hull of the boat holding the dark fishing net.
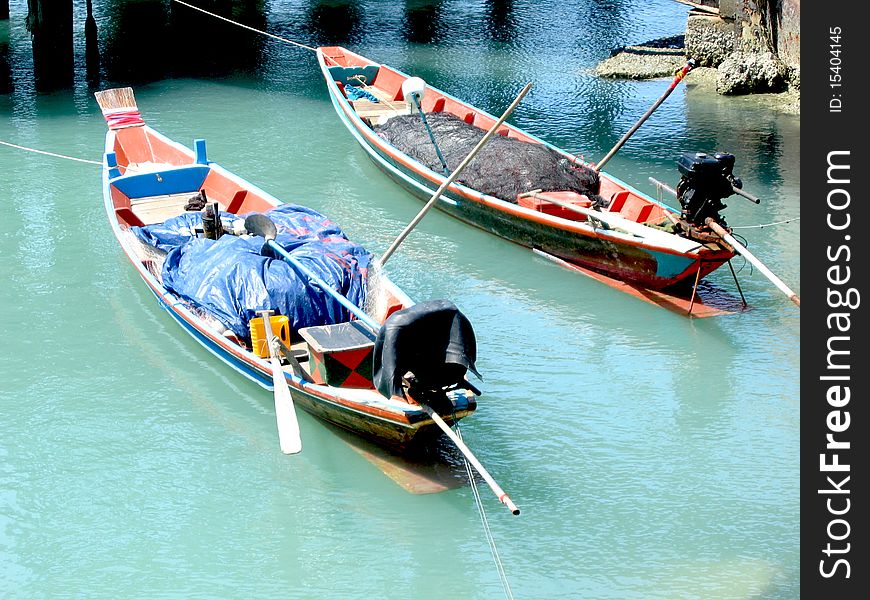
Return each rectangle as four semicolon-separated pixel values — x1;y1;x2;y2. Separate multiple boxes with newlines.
317;46;734;316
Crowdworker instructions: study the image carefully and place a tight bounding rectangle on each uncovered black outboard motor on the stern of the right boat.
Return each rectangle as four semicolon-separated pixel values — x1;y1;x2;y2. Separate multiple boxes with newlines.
677;152;743;233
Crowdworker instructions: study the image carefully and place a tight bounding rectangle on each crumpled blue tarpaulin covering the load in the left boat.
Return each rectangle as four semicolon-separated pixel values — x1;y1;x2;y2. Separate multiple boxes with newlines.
131;204;371;339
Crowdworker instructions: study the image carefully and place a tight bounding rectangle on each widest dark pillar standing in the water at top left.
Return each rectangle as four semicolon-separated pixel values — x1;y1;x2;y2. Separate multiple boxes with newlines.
27;0;73;91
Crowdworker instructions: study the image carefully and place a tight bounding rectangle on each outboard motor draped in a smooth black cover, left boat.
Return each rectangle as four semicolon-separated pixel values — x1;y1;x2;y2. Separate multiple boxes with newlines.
373;300;480;412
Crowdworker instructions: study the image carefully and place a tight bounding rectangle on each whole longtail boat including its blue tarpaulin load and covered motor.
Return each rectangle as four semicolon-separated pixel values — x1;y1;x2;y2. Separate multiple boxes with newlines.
97;88;479;451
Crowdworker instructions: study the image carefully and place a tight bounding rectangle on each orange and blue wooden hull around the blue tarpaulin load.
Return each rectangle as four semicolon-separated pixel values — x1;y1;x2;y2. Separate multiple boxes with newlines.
98;88;476;451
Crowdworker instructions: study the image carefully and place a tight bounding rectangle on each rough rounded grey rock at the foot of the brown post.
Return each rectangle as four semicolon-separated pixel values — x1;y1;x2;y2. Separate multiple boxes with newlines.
716;52;786;95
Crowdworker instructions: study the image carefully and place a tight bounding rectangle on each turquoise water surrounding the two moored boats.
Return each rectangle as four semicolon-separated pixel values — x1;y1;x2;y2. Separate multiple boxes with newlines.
0;0;800;599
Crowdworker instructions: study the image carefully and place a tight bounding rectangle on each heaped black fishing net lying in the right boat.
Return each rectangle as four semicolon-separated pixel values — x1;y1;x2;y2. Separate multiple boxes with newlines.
375;113;602;204
